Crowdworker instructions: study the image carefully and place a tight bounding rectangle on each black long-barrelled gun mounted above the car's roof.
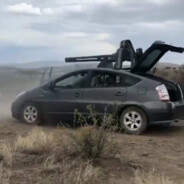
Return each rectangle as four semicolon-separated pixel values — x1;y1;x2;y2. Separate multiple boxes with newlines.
65;40;136;69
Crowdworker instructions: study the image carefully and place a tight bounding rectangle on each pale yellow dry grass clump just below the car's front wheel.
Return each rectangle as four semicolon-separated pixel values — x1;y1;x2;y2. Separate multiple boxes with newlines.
15;128;53;154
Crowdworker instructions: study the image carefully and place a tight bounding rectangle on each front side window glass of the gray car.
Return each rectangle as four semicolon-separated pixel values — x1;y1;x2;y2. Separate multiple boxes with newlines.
55;72;87;88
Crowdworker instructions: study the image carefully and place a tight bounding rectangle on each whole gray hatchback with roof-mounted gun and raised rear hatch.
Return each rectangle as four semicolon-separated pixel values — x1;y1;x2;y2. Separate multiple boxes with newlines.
11;41;184;134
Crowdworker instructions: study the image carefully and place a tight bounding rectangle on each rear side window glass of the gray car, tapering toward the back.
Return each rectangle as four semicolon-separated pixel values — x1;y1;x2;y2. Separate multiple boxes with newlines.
90;71;140;87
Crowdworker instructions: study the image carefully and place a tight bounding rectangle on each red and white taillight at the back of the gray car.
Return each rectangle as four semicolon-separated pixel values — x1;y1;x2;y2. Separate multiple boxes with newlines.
156;84;170;102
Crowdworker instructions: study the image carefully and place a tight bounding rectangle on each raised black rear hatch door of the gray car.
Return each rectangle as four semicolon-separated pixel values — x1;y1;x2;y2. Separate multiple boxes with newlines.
131;41;184;73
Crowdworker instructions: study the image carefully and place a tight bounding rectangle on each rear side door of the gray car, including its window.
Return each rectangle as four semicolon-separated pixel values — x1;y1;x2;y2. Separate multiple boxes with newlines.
83;70;127;115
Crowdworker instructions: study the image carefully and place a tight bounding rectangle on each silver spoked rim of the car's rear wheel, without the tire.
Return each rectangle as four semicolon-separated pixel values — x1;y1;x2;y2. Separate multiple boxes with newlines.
123;111;142;131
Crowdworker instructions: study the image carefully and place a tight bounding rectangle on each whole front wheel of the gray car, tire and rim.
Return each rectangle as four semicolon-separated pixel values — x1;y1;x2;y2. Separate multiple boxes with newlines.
21;103;41;125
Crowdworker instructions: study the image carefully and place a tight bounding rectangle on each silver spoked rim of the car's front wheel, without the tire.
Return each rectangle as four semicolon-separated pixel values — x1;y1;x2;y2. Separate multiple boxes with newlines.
24;105;38;124
